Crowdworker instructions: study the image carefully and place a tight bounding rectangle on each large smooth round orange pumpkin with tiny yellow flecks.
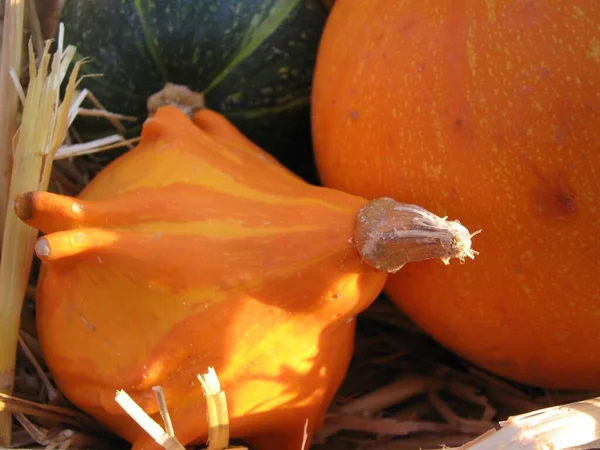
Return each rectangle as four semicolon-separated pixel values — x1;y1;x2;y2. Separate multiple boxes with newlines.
312;0;600;389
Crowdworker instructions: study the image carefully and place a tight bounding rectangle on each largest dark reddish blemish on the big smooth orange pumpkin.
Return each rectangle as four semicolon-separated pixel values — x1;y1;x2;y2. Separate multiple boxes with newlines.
532;166;577;220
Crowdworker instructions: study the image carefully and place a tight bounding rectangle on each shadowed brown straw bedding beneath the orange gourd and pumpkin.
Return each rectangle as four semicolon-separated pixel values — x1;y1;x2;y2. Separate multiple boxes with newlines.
9;290;600;450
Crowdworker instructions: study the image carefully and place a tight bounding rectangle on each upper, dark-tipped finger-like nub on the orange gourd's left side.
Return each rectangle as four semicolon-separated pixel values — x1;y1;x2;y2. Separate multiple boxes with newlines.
13;191;84;233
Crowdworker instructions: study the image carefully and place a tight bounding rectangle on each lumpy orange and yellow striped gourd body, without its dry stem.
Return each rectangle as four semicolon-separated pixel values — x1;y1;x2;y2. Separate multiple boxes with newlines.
32;106;386;450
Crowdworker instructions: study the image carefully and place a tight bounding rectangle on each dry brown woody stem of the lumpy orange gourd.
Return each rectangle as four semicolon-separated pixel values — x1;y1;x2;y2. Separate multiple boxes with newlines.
354;197;480;273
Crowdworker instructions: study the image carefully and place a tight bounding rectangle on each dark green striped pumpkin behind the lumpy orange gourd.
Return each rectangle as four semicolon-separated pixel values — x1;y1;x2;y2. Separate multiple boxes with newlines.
62;0;327;181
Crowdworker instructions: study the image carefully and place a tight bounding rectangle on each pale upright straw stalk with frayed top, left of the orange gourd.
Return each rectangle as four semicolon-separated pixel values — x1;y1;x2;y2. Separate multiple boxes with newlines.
0;23;81;444
